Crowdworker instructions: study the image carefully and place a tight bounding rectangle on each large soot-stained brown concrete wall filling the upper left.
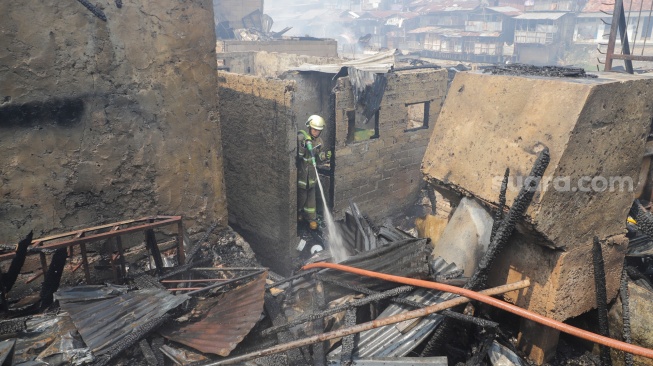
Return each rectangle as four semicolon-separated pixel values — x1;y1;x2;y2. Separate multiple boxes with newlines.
0;0;227;242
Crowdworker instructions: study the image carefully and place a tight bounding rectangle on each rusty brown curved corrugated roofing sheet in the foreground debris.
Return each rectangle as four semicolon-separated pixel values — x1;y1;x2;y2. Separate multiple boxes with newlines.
161;272;267;357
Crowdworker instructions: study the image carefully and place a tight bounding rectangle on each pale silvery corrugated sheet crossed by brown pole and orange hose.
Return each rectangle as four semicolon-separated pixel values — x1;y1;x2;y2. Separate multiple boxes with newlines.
329;258;458;358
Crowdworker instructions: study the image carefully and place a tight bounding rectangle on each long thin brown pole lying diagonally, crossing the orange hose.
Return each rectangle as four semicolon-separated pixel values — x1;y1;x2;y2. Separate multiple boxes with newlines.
205;280;530;366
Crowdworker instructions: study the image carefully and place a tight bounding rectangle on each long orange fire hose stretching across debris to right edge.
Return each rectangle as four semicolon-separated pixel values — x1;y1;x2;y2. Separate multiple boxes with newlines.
302;263;653;359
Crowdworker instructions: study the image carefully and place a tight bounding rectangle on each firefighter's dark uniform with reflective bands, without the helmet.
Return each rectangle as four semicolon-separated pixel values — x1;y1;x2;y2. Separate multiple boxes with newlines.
297;130;327;221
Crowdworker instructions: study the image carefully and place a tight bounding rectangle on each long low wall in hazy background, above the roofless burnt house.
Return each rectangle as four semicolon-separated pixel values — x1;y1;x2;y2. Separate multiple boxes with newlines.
216;39;338;57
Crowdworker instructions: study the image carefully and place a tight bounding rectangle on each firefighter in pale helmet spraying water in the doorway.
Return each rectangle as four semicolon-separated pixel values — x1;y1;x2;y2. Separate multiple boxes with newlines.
297;115;331;230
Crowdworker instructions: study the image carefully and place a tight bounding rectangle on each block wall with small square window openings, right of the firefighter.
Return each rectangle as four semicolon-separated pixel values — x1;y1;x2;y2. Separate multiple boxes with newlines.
334;69;447;219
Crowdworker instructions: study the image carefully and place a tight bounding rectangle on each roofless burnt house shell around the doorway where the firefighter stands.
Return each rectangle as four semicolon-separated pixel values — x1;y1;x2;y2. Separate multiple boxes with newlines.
218;52;447;272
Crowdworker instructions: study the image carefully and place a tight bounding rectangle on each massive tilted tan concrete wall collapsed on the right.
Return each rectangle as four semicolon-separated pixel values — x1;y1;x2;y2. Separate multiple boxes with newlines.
423;72;653;320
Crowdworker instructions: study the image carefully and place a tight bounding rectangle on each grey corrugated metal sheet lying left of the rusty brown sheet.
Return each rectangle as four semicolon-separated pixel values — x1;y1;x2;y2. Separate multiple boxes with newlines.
60;289;188;355
